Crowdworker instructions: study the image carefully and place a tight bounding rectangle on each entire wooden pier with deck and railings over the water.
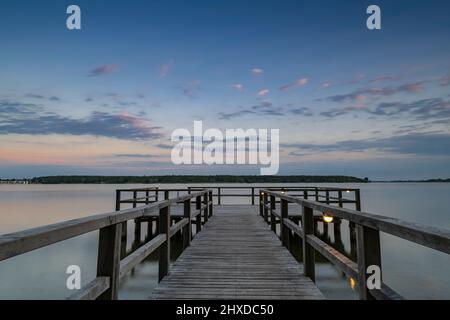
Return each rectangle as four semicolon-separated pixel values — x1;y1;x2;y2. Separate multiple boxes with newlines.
0;186;450;300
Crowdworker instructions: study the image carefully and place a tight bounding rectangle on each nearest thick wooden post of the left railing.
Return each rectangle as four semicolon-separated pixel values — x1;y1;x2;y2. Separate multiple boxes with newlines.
97;224;122;300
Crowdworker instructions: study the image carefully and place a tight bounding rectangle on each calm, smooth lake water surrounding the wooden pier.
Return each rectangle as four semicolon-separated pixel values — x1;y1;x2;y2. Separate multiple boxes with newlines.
0;183;450;299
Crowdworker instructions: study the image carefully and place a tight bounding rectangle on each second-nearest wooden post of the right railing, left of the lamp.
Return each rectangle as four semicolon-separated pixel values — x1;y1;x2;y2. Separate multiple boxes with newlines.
302;207;315;282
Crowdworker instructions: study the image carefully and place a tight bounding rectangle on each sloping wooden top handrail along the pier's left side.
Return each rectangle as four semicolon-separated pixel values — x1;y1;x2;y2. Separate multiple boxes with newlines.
0;189;209;261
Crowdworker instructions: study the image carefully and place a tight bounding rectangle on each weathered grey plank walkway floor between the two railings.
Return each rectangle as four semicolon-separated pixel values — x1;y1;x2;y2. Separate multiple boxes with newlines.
151;205;324;300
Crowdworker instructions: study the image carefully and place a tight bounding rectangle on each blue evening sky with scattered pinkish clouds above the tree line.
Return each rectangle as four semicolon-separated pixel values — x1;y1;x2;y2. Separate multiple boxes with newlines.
0;0;450;180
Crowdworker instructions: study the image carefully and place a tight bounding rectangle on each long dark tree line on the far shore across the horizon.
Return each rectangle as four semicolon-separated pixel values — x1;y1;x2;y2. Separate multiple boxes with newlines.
30;175;369;184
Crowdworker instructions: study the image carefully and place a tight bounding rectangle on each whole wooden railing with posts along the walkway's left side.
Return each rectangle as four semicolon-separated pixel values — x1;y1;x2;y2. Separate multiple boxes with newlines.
0;189;213;300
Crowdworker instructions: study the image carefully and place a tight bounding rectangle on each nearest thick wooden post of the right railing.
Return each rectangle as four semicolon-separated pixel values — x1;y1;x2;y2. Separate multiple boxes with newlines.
356;225;381;300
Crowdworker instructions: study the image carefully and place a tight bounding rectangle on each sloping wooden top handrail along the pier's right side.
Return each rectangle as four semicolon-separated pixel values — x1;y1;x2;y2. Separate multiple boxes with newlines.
260;189;450;254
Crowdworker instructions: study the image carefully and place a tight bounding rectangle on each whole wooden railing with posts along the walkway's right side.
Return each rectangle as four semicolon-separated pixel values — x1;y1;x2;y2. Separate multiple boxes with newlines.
259;189;450;300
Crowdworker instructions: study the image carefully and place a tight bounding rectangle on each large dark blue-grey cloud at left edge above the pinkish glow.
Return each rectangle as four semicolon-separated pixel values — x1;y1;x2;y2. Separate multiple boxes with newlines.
0;101;161;140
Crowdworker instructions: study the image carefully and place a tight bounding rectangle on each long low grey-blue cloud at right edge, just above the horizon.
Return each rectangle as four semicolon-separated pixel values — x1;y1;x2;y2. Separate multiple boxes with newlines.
280;133;450;157
